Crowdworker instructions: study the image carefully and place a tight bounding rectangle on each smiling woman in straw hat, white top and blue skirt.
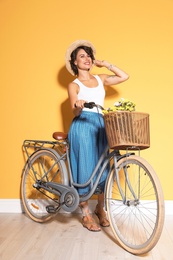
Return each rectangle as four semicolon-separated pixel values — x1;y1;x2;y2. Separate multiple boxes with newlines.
66;40;128;231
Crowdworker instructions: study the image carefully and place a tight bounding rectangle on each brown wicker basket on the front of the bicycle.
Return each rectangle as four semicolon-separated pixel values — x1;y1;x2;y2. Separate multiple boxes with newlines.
104;111;150;150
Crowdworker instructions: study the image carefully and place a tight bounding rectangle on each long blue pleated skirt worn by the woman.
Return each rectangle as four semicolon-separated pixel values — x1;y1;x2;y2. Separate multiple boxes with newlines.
68;111;108;195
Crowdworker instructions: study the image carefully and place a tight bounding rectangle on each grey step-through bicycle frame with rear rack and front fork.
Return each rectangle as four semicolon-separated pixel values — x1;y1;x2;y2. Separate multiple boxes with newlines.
23;140;133;203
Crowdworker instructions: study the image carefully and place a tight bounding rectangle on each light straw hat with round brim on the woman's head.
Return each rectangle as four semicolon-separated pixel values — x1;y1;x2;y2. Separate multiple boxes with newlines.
65;40;96;75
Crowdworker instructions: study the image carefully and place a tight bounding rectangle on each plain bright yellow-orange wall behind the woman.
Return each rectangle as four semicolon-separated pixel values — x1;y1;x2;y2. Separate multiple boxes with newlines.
0;0;173;200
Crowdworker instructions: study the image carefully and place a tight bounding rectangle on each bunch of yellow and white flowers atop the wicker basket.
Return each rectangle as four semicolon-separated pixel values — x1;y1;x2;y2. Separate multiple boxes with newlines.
103;98;136;114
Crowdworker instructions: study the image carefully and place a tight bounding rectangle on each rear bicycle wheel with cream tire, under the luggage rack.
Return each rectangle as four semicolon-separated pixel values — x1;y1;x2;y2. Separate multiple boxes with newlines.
21;149;67;222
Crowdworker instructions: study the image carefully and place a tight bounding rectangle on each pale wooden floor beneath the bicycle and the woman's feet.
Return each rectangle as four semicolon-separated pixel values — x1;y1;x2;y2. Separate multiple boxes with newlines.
0;213;173;260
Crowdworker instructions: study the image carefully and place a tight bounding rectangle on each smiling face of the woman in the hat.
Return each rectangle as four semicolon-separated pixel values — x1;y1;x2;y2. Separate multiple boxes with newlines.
74;49;92;71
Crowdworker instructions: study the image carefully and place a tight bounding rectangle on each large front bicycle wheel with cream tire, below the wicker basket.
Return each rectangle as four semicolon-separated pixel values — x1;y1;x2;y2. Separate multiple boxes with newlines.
106;156;164;255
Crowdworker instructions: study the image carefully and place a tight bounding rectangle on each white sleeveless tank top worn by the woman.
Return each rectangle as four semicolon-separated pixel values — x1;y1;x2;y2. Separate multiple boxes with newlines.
73;75;105;113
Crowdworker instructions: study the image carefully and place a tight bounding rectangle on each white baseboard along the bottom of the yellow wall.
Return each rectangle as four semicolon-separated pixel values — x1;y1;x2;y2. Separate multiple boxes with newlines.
0;199;173;215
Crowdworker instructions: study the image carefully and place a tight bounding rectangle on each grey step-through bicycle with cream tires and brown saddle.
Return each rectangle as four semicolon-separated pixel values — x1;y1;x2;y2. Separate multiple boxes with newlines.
21;102;164;255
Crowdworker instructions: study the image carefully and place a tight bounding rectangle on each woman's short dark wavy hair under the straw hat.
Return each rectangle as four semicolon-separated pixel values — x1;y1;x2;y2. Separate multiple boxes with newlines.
70;46;95;75
